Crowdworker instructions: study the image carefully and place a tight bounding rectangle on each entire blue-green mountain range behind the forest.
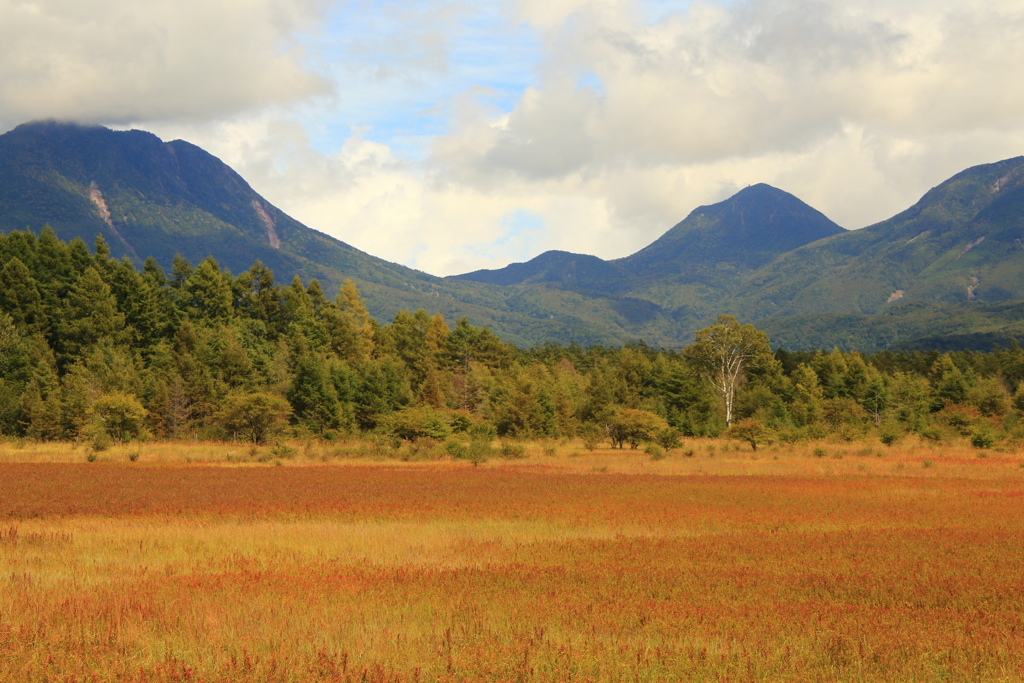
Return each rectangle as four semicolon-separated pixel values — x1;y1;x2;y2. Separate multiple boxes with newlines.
0;121;1024;351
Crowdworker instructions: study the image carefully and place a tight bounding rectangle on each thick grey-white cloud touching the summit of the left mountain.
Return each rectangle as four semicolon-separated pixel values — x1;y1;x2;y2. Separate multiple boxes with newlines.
0;0;329;127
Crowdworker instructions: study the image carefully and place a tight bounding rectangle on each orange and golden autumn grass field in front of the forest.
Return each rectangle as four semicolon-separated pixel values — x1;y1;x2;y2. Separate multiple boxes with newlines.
0;441;1024;682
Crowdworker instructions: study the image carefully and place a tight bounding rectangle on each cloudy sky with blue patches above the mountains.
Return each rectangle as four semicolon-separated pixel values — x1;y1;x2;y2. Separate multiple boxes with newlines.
0;0;1024;275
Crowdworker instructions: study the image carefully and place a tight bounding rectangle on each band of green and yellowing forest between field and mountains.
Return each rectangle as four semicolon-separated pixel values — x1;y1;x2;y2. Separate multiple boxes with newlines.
0;227;1024;459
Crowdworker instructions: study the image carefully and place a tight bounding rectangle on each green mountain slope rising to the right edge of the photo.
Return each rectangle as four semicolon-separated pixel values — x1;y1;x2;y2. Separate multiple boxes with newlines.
736;158;1024;317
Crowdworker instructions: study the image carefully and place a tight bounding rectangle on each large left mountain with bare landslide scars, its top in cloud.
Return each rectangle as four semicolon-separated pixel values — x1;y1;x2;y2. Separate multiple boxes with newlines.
0;122;629;344
